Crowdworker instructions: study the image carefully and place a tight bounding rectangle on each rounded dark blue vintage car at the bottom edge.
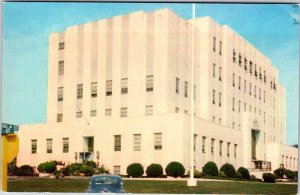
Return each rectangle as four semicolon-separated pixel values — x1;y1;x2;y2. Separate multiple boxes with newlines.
87;174;125;193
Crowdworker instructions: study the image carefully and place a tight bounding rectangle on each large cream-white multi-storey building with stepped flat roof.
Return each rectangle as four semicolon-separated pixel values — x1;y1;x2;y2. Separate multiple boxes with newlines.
17;9;298;174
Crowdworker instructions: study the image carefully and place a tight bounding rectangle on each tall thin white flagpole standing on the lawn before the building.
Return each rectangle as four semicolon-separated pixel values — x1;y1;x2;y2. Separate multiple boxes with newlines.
187;3;197;186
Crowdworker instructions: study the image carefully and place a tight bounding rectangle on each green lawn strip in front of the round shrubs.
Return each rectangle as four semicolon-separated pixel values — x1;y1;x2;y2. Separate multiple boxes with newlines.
8;178;297;194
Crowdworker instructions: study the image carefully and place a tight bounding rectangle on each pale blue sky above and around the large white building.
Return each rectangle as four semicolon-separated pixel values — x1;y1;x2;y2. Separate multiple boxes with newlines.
2;2;299;144
